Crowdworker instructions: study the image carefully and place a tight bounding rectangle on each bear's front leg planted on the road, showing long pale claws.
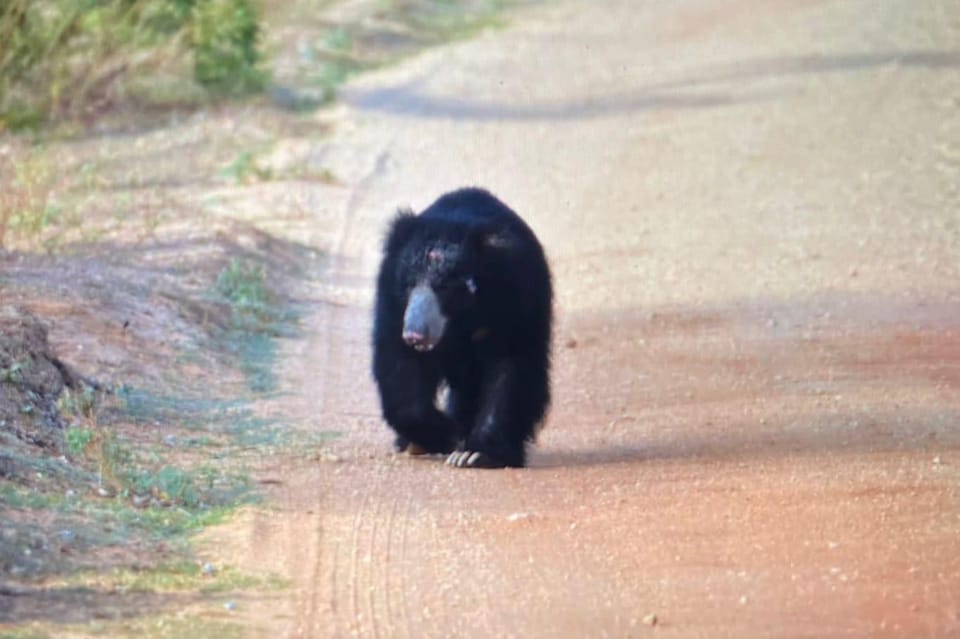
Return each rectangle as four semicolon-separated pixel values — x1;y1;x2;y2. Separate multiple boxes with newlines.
447;362;549;468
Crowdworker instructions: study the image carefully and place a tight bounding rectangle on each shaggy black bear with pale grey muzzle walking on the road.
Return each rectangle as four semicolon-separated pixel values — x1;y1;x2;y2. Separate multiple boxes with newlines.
373;188;553;468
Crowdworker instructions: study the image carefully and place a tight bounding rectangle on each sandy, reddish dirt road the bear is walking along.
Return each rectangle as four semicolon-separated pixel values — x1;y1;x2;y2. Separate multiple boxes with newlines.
205;0;960;638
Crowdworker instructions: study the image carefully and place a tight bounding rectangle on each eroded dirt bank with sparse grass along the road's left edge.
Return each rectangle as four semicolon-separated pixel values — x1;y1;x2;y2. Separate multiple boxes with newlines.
0;224;313;632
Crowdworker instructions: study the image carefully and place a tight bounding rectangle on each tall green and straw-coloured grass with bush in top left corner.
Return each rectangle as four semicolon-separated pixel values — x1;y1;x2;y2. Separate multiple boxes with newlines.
0;0;267;130
